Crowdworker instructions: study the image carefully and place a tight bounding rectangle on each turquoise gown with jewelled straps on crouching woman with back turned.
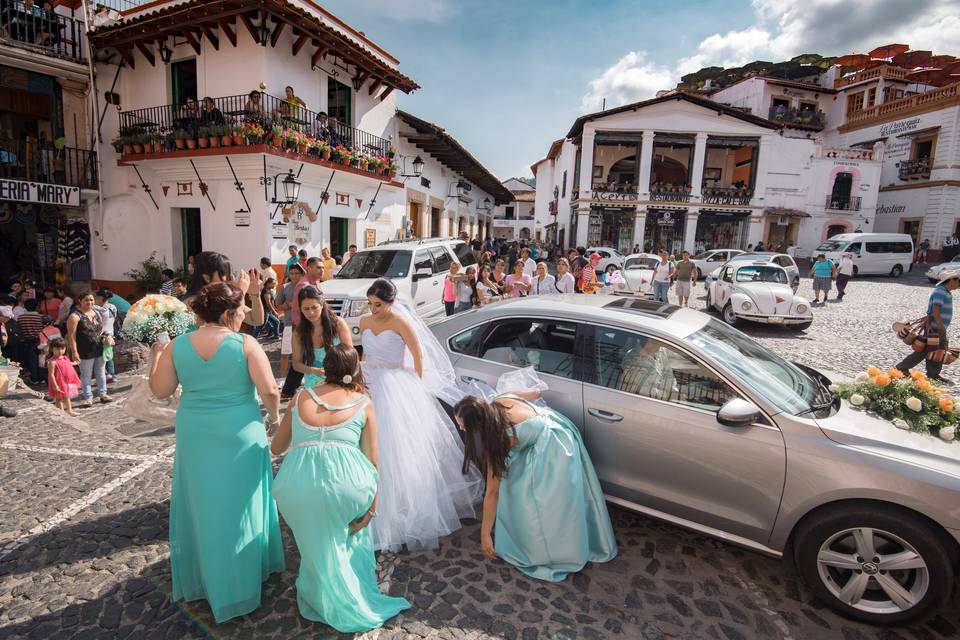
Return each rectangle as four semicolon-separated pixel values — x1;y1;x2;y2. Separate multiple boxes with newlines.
273;387;410;633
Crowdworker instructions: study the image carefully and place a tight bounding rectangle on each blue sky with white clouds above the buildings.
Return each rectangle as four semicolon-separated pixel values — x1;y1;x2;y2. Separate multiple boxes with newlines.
321;0;960;179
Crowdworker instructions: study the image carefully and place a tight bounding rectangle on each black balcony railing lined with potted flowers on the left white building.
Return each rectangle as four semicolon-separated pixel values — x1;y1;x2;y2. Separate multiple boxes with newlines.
115;92;395;162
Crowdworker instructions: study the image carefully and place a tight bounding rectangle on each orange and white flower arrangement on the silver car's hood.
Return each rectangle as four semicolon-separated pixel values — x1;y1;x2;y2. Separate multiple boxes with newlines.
831;367;960;442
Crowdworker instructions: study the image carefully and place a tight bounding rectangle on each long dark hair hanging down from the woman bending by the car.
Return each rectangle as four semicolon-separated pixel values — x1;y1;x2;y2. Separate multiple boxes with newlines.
453;396;513;478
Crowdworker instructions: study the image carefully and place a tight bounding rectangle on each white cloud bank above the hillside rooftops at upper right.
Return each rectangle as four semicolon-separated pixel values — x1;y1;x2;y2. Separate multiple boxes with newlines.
581;0;960;112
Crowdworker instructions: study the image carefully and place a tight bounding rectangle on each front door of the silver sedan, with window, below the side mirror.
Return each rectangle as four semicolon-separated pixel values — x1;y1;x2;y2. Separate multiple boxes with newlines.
583;326;786;543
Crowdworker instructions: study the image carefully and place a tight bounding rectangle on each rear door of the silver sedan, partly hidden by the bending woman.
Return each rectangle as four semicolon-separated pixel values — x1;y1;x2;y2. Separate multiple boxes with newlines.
449;317;586;427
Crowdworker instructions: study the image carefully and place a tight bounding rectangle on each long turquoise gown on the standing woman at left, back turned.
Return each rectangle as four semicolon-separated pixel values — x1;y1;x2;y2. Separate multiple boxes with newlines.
170;333;284;623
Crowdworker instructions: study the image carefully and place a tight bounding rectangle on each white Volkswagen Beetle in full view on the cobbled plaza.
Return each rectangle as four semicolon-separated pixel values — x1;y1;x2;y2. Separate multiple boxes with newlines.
707;261;813;331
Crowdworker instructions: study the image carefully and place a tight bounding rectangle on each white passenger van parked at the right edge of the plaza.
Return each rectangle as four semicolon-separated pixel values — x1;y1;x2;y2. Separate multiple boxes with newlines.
811;233;913;278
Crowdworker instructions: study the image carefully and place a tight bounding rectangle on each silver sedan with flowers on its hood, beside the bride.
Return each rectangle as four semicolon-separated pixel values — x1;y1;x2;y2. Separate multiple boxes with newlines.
431;294;960;624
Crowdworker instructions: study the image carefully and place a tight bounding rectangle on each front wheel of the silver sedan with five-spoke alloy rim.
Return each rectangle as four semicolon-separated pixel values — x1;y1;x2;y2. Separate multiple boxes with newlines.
794;504;954;625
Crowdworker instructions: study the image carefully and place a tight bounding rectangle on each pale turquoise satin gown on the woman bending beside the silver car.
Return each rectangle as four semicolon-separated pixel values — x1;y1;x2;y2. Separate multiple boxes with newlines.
494;396;617;582
